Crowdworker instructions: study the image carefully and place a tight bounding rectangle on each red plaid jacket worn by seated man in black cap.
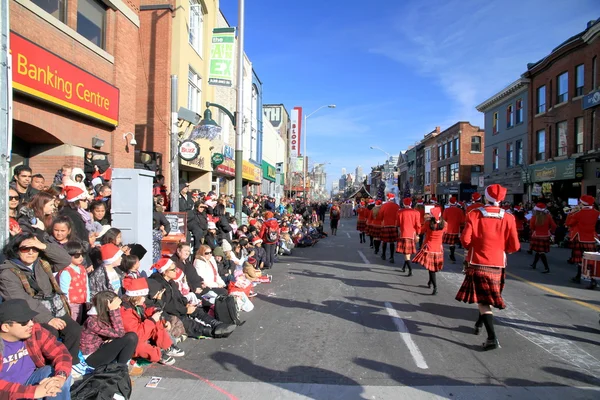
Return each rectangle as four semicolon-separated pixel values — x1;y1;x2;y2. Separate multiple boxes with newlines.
0;323;71;400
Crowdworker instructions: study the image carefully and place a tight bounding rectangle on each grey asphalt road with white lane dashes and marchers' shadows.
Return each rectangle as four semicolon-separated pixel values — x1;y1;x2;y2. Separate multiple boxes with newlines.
133;218;600;400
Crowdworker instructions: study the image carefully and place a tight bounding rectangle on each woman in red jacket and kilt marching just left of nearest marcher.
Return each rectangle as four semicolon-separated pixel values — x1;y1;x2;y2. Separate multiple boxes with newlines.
413;207;447;295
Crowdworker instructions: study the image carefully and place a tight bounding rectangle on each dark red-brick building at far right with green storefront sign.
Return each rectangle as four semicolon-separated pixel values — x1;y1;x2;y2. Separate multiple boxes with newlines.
523;19;600;201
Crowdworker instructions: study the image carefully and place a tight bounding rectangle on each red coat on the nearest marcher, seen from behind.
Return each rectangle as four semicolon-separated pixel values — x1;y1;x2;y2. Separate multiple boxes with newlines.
460;206;521;268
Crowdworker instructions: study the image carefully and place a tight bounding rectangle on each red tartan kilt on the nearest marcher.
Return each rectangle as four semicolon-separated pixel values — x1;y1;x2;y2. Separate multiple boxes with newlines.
456;264;506;310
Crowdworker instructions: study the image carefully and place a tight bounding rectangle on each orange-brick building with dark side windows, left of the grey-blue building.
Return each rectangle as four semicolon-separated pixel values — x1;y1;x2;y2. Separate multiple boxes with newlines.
432;122;484;202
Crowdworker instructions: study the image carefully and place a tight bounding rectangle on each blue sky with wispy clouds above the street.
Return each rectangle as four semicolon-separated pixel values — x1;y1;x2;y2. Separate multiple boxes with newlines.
220;0;600;189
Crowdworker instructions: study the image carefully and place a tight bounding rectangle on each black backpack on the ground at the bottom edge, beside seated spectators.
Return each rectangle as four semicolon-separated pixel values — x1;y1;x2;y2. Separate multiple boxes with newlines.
71;363;131;400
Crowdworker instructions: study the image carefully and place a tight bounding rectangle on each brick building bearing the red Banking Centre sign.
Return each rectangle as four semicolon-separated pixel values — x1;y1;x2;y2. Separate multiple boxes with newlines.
10;0;139;179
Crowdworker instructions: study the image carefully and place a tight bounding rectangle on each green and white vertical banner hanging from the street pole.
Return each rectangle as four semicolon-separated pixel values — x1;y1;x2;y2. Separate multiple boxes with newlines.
208;28;235;86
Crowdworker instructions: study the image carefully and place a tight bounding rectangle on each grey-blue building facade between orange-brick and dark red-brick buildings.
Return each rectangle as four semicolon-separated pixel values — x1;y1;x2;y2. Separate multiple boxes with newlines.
477;78;530;204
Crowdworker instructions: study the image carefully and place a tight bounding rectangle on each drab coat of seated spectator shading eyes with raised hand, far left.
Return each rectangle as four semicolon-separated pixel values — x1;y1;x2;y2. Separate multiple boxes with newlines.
0;243;71;324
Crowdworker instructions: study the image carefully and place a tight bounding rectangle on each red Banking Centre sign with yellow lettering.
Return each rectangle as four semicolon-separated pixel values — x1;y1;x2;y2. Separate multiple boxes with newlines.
10;32;119;126
